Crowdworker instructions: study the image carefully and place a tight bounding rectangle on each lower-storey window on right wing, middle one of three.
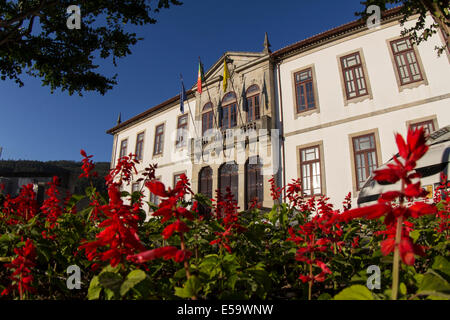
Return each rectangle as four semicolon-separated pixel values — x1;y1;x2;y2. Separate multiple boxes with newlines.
352;133;378;190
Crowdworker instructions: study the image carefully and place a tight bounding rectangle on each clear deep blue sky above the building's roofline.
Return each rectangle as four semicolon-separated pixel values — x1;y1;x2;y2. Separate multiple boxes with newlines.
0;0;380;161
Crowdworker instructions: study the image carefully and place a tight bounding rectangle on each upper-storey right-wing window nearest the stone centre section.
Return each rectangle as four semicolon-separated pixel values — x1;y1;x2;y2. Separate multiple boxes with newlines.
294;68;316;113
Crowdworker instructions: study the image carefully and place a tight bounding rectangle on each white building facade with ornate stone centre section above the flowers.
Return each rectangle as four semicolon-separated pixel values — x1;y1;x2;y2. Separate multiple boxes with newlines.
108;9;450;209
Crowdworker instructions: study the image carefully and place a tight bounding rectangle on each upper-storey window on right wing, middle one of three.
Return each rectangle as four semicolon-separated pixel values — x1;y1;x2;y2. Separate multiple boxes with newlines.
341;52;369;99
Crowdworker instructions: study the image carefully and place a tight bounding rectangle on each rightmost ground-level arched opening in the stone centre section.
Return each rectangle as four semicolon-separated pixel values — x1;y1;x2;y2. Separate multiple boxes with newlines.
245;156;264;209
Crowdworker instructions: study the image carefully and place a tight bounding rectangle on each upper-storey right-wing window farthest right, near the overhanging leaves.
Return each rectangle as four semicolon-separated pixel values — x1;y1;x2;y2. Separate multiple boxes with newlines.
391;38;423;85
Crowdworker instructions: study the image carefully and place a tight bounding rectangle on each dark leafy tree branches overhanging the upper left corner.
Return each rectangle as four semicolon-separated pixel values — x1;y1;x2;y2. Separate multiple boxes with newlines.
0;0;182;95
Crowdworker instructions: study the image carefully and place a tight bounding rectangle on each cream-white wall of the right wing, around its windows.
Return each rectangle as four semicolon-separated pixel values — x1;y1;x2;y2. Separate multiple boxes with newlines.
280;18;450;207
